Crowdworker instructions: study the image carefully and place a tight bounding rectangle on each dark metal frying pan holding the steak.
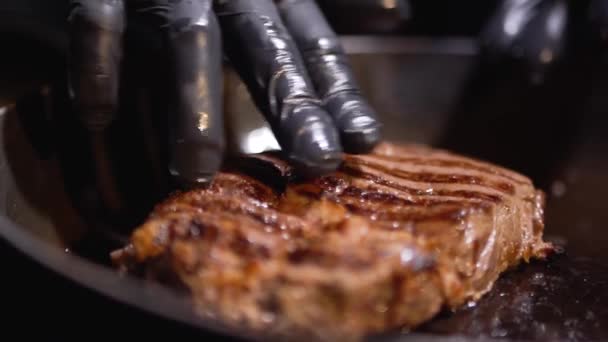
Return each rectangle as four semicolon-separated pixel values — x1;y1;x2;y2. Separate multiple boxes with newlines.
0;2;608;341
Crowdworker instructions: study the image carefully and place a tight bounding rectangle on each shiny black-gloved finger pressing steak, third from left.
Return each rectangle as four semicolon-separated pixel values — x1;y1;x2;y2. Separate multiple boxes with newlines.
215;0;342;176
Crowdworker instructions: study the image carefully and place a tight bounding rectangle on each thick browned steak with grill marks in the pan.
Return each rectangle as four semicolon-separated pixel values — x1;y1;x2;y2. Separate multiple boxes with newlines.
113;143;552;338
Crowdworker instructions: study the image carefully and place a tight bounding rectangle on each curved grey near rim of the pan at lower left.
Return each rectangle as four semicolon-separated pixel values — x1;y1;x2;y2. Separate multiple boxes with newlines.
0;215;260;340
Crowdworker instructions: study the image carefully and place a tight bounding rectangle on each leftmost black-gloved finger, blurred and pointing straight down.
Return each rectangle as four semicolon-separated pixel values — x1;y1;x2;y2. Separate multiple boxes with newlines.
68;0;125;211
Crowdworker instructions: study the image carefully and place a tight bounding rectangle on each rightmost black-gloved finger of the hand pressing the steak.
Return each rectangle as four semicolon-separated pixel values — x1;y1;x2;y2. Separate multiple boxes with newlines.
278;0;381;153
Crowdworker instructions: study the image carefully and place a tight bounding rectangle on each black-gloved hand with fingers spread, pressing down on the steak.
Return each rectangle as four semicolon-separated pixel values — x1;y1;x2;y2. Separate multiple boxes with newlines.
69;0;381;195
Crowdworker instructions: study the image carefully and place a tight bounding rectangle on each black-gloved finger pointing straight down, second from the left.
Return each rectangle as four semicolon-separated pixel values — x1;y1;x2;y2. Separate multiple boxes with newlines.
131;0;224;187
